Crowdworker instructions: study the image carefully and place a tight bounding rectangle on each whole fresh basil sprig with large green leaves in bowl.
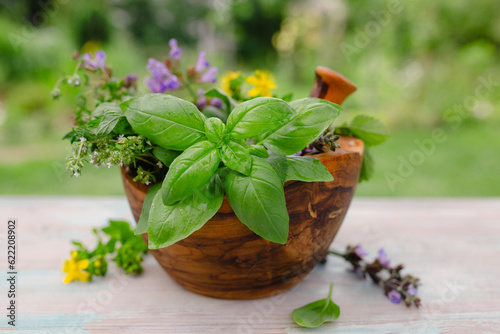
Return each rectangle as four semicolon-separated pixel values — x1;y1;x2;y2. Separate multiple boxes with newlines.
120;91;341;249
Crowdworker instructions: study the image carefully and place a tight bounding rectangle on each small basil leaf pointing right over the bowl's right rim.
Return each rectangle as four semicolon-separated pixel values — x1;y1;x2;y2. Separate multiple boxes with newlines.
286;156;333;182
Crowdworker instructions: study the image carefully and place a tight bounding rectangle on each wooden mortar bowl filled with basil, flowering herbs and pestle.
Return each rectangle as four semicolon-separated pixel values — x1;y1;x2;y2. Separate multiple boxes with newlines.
53;40;385;299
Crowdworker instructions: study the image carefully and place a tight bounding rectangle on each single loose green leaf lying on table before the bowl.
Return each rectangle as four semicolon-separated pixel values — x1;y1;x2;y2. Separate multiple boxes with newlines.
292;283;340;328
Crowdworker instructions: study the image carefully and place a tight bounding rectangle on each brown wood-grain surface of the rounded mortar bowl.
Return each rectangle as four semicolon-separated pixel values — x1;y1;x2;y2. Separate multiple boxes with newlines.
122;138;363;299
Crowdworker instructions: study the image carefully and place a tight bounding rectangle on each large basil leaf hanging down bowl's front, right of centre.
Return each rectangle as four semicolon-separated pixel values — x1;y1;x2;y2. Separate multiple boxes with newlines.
223;157;289;244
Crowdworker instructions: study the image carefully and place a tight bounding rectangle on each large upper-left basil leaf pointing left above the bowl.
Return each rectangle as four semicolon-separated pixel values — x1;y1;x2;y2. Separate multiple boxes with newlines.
120;94;206;151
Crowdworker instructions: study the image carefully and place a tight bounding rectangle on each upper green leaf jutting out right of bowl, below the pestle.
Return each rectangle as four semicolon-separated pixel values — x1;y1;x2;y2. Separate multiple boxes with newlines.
335;115;389;146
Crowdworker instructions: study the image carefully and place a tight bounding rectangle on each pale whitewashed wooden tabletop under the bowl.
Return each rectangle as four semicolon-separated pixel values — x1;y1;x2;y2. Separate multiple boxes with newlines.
0;197;500;334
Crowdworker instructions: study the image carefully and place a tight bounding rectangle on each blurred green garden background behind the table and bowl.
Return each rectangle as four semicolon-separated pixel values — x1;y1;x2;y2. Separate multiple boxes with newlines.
0;0;500;196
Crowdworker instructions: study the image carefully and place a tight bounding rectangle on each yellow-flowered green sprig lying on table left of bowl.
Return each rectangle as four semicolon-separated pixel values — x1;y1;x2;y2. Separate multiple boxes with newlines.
63;220;148;283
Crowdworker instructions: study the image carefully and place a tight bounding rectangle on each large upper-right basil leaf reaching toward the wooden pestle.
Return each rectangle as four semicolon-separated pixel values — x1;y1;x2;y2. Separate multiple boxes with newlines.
259;97;341;155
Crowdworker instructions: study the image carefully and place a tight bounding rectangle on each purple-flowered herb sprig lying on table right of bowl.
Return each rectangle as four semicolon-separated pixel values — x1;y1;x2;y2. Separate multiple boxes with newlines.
330;245;421;307
